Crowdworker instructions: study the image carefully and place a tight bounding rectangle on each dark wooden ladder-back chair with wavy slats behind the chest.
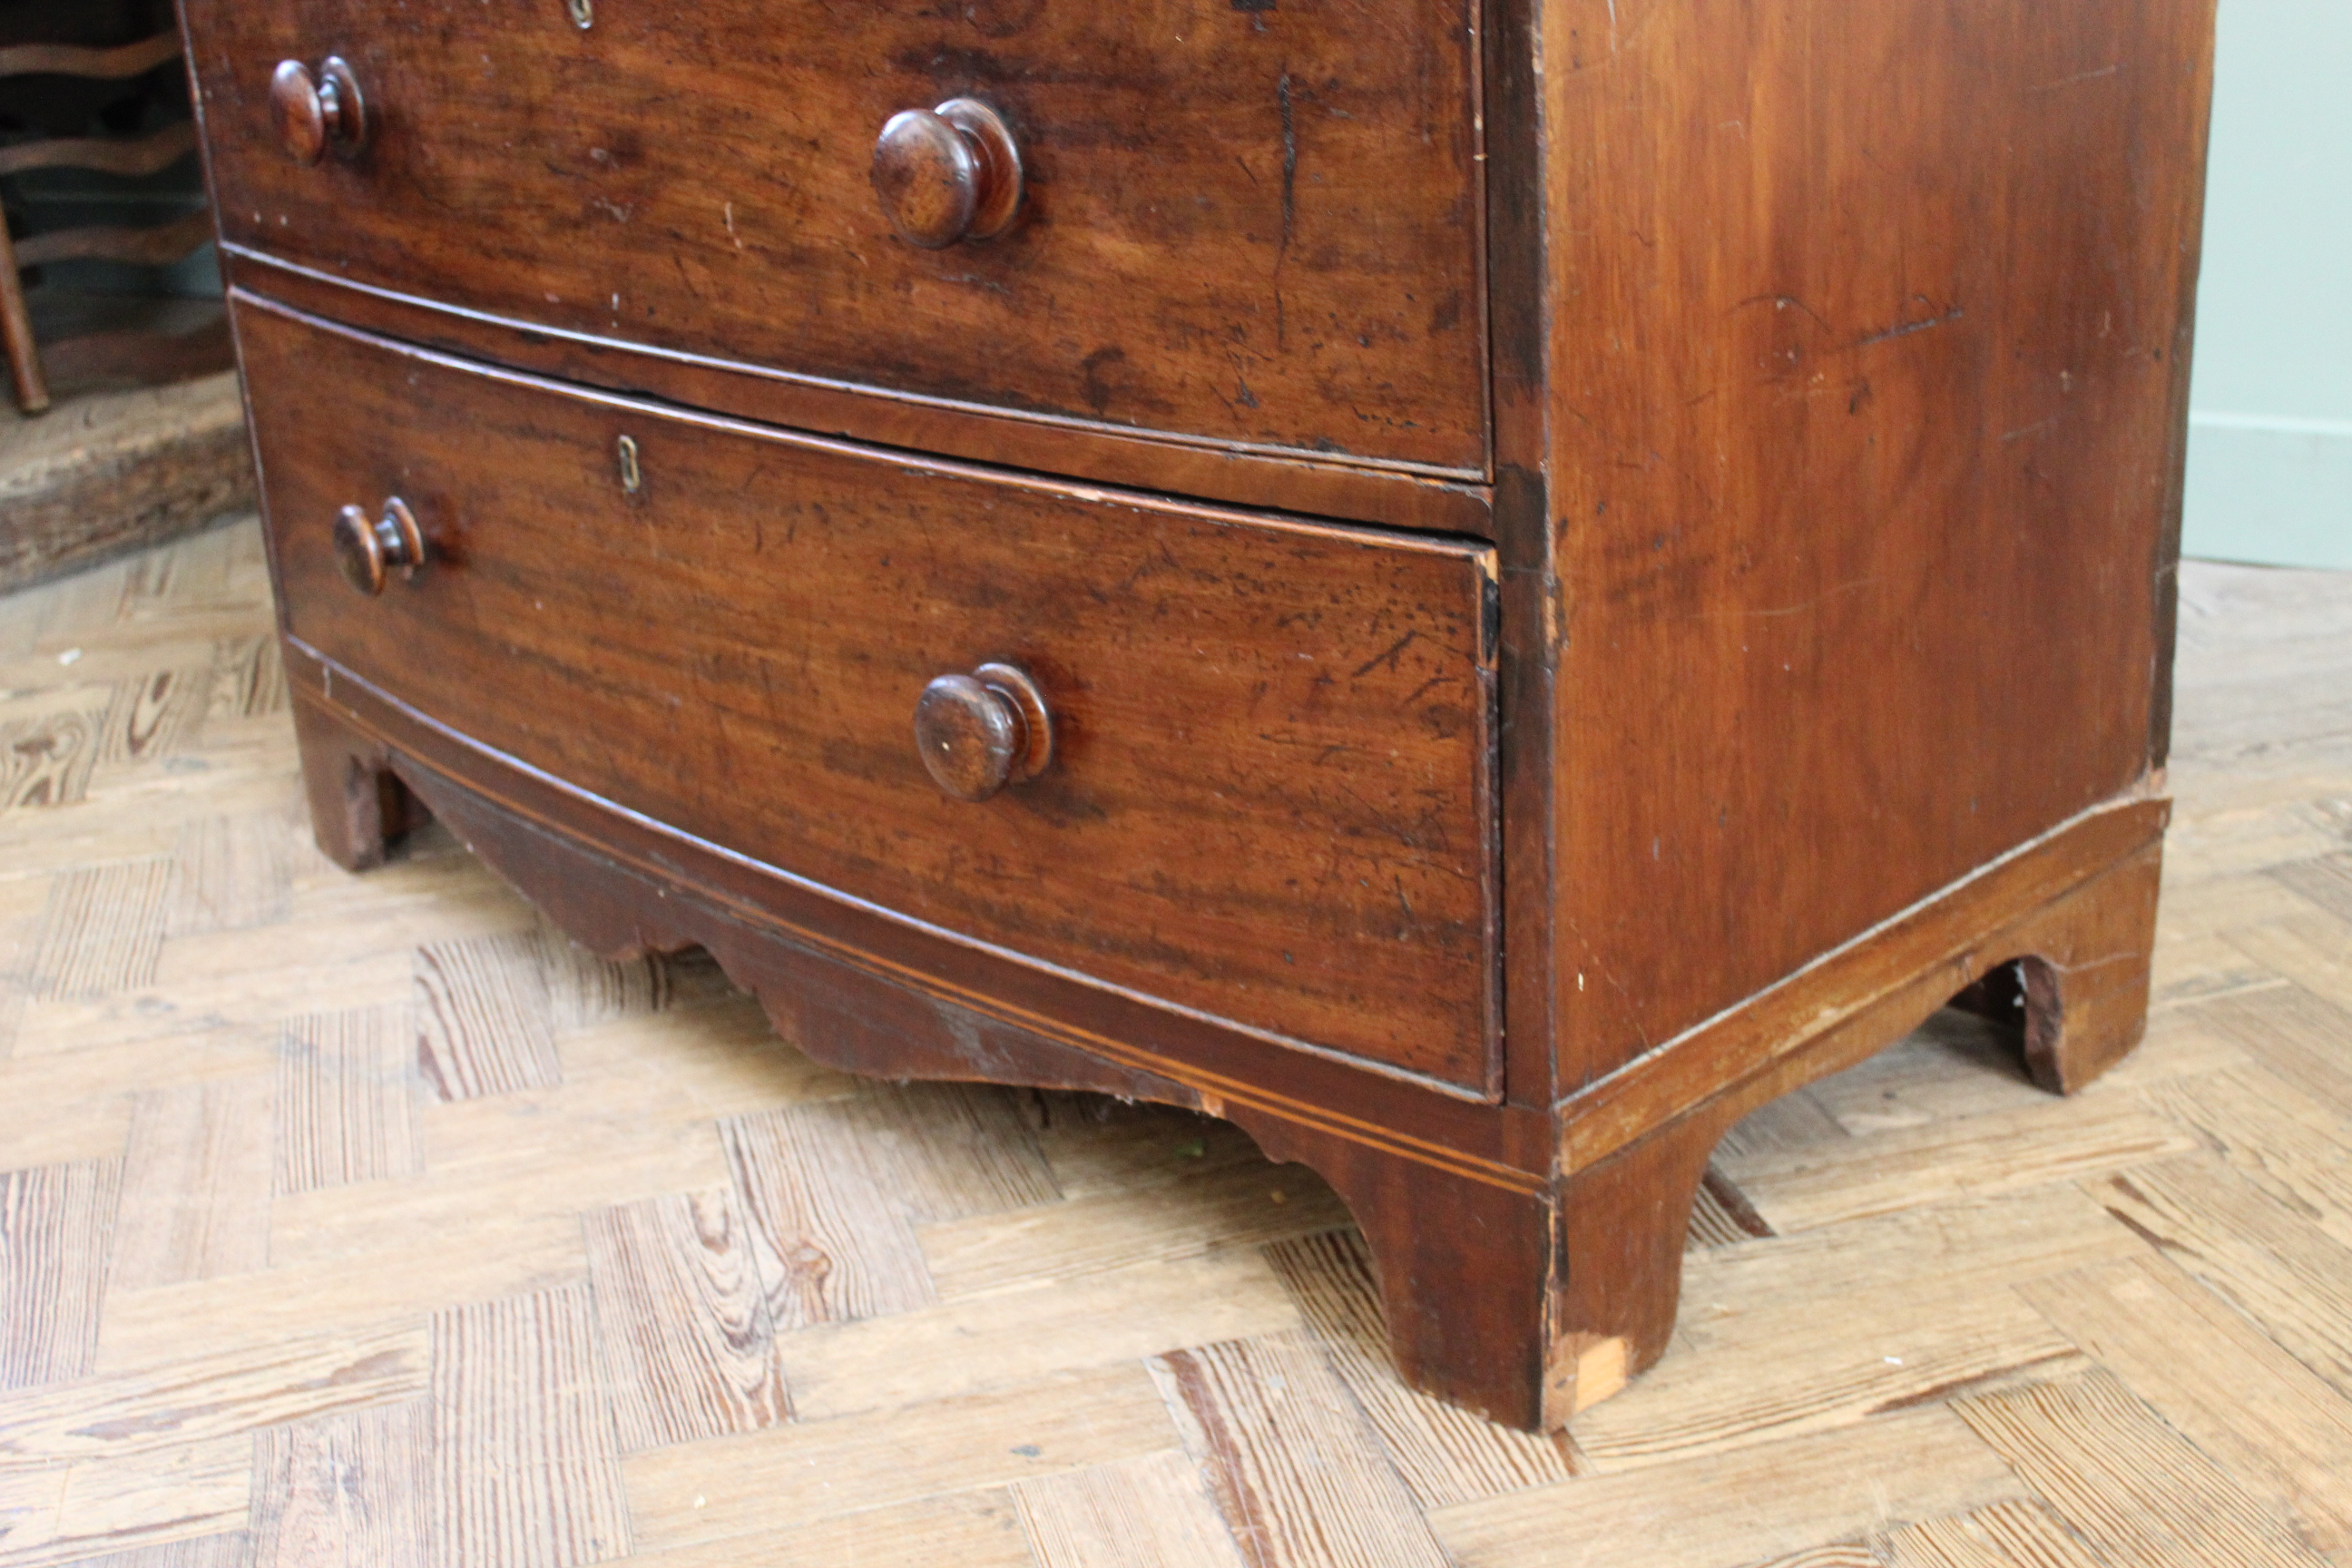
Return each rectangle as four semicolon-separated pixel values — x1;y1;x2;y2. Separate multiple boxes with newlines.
0;33;228;414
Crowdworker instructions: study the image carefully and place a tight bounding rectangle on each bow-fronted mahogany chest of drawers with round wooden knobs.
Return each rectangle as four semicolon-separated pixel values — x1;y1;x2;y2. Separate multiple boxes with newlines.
183;0;2210;1427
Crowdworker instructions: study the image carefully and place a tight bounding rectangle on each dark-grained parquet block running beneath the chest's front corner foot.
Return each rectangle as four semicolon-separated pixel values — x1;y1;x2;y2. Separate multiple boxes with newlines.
1265;1230;1573;1509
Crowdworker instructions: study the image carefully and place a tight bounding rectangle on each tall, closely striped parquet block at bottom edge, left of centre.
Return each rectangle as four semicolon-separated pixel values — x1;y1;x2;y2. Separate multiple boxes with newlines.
430;1286;631;1568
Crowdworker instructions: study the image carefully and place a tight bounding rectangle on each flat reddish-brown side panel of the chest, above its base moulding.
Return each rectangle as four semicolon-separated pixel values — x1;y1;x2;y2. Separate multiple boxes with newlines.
1533;0;2213;1088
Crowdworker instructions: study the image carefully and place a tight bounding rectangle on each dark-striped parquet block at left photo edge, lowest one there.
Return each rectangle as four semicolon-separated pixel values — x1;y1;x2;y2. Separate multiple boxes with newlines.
0;1159;122;1389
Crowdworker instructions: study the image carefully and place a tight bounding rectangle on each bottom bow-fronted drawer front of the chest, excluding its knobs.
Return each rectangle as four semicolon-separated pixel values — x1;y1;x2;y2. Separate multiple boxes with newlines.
238;301;1496;1095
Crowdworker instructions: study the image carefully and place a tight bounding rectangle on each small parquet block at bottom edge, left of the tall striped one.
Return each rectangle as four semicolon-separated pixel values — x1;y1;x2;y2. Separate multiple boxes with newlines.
251;1398;433;1568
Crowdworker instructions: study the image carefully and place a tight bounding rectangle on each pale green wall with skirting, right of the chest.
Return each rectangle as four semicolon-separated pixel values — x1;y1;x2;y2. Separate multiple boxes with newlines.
2180;0;2352;566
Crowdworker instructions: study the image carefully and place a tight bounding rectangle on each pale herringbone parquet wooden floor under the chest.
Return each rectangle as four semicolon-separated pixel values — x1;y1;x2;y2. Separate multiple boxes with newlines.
0;524;2352;1568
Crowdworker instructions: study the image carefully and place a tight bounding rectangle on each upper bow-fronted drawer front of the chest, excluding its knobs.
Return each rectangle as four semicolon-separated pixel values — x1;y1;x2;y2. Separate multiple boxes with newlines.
197;0;1486;475
